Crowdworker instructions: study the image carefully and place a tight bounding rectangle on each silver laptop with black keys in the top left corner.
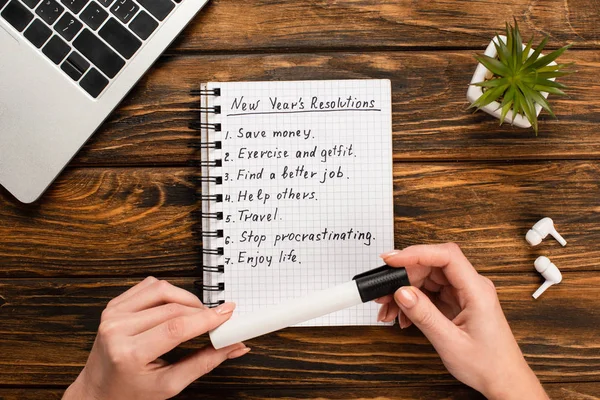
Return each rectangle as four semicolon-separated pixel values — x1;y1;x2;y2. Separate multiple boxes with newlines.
0;0;208;203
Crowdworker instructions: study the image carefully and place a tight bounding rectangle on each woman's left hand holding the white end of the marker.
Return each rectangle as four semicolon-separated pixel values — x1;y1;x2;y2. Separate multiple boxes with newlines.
63;277;250;400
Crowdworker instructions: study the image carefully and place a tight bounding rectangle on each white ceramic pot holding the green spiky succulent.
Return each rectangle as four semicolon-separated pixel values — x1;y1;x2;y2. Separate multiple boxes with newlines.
467;35;556;128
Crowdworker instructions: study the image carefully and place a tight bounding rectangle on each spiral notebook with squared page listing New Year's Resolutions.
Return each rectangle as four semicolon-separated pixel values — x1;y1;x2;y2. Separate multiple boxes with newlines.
197;80;394;326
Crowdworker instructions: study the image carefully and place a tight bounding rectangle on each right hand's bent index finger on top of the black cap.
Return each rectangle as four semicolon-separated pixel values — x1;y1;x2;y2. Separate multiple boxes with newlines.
385;243;481;290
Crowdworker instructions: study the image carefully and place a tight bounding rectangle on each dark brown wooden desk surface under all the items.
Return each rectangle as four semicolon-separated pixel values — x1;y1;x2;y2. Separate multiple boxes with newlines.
0;0;600;400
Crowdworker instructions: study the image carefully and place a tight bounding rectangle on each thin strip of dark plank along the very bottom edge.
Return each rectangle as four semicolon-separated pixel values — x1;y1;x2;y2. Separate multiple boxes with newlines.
0;382;600;400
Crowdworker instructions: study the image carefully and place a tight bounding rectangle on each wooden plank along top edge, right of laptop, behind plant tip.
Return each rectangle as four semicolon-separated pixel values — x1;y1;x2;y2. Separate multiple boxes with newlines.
171;0;600;52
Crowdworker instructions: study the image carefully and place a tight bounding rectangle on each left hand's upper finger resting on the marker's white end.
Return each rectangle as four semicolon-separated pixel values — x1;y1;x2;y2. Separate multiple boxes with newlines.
133;303;235;364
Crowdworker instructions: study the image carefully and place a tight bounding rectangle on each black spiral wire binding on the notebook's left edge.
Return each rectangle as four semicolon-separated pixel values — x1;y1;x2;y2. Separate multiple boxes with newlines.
189;85;225;307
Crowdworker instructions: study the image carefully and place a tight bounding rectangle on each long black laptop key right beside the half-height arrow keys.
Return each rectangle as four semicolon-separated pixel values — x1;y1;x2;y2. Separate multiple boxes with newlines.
73;28;125;79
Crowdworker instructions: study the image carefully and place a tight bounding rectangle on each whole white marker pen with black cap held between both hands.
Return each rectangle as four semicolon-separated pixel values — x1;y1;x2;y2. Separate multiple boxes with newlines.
209;265;410;349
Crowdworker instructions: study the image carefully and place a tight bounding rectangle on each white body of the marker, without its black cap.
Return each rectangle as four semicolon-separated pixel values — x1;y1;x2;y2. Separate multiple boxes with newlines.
209;281;362;349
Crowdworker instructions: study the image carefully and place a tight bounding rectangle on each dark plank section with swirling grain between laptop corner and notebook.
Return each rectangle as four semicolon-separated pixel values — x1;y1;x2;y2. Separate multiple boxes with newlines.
0;168;200;277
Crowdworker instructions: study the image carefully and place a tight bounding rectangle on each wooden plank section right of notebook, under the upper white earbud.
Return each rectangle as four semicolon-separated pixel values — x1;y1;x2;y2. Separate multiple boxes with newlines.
394;161;600;273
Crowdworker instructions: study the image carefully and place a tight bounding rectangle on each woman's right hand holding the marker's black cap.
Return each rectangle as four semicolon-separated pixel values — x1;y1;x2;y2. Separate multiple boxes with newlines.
378;243;548;400
